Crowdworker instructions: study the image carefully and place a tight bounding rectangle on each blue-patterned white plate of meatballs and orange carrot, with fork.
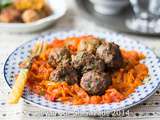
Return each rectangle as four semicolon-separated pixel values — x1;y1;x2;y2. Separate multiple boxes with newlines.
4;31;160;115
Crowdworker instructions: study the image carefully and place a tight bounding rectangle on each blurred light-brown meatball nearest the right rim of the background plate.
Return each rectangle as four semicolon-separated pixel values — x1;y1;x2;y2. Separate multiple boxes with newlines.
22;9;41;23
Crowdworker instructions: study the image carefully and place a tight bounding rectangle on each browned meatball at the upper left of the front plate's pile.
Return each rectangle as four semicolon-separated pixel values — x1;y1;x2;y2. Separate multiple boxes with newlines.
48;47;71;67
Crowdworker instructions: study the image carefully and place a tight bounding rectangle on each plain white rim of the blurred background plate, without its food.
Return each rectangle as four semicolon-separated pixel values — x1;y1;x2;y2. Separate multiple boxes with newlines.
0;0;67;32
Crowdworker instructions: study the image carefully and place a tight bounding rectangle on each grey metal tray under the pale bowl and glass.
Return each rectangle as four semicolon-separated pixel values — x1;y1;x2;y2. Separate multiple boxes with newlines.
76;0;160;36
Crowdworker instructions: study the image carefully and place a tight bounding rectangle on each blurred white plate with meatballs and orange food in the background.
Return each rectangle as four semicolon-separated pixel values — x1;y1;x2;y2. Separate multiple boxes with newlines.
0;0;66;32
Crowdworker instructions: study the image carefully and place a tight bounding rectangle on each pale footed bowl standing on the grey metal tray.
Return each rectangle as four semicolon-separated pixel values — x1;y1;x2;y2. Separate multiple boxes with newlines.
90;0;129;15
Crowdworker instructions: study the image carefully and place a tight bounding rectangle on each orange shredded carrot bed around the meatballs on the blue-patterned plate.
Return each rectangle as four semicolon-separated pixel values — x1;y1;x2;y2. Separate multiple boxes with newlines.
24;36;148;105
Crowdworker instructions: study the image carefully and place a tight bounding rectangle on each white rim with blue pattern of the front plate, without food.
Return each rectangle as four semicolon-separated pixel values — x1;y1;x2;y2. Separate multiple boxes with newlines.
4;31;160;115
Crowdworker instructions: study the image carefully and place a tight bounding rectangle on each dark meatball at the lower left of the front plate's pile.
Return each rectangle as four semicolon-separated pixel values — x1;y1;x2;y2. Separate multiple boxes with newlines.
50;64;79;85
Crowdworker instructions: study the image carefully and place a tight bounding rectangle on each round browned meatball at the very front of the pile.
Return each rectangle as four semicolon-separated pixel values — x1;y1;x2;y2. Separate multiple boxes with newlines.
80;70;111;95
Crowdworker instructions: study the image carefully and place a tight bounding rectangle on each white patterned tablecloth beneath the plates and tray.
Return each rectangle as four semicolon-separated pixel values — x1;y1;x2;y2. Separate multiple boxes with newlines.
0;0;160;120
